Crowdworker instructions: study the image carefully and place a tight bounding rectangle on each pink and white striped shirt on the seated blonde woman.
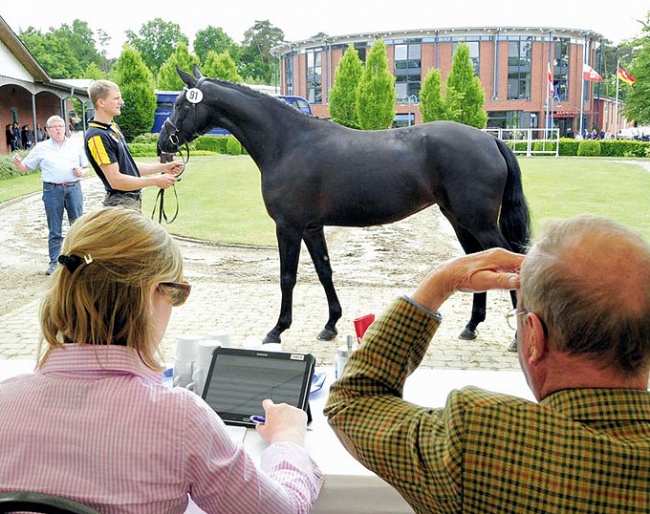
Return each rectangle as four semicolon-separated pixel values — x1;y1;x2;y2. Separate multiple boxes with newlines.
0;346;323;514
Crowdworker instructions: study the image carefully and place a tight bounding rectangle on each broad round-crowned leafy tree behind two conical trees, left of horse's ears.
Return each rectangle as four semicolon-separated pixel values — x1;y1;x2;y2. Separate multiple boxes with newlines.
126;18;189;75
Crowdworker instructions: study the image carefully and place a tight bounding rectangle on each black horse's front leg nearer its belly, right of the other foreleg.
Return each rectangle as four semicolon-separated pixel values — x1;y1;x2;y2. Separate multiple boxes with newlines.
302;227;343;341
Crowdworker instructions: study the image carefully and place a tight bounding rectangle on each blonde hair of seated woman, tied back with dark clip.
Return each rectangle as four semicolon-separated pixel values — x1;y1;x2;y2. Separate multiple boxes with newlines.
38;207;183;370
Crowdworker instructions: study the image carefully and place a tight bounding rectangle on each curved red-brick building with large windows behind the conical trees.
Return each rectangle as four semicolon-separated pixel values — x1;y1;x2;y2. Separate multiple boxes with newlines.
272;27;626;135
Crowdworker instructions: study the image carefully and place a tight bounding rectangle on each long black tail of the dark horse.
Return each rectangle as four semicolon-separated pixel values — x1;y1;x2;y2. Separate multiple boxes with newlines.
495;138;530;253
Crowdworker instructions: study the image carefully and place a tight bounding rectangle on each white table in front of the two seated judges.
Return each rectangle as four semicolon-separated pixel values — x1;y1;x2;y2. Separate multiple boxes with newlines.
0;360;534;514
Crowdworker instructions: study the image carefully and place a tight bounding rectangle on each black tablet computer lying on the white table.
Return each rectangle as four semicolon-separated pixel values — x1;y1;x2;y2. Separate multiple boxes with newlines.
202;347;316;427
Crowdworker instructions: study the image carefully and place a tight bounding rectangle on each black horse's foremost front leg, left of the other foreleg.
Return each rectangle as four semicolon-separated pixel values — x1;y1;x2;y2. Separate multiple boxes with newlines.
262;226;301;344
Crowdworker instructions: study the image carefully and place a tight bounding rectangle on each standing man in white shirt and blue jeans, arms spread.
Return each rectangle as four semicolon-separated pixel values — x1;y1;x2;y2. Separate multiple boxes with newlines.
11;116;88;275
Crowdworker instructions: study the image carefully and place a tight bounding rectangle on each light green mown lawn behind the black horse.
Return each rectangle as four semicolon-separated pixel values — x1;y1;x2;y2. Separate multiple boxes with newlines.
0;155;650;242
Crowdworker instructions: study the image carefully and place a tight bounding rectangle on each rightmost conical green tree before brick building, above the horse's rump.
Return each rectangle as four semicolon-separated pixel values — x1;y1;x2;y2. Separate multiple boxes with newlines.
445;43;488;129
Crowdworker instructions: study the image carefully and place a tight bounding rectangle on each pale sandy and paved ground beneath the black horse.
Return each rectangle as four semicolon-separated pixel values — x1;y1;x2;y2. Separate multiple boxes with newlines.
0;172;518;369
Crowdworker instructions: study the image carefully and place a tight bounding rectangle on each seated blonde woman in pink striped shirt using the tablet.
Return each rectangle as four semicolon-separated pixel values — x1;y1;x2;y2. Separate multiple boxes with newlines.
0;207;323;514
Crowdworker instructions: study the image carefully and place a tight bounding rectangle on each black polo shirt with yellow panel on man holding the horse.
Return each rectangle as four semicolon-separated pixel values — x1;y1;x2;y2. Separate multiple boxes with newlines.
84;120;140;193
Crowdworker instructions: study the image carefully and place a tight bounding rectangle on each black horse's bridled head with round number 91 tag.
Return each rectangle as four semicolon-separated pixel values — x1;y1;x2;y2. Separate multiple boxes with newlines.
158;65;214;153
